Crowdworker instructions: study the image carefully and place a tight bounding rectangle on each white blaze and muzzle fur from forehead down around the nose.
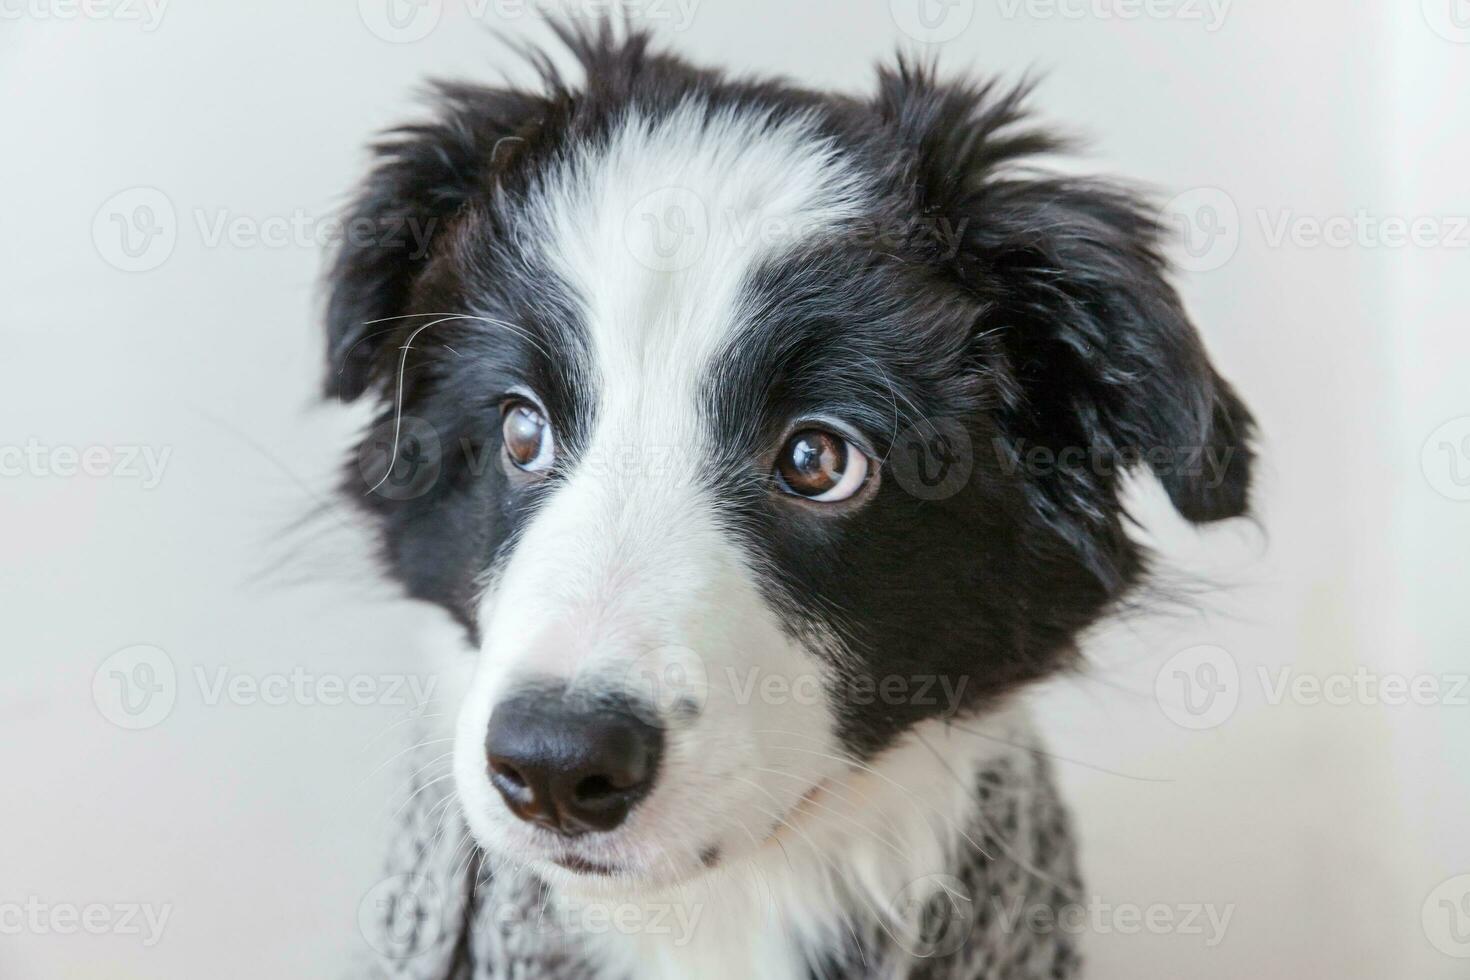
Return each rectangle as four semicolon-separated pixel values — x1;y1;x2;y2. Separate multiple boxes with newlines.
454;103;867;893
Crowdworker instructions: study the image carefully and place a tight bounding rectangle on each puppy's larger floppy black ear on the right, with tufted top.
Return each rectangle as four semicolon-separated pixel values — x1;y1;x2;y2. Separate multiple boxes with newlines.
878;63;1254;522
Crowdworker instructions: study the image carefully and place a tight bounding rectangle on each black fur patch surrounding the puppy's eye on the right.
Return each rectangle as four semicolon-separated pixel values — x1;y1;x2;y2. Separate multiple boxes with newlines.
706;244;1111;755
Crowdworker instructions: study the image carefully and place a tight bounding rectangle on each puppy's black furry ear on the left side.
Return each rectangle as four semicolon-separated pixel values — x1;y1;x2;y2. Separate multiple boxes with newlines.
325;84;551;401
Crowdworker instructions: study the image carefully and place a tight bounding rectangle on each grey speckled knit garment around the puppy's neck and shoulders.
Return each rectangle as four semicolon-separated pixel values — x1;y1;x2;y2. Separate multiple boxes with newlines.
360;740;1080;980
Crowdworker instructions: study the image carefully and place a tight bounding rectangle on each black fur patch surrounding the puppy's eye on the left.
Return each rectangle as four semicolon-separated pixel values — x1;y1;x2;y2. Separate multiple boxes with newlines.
343;257;597;636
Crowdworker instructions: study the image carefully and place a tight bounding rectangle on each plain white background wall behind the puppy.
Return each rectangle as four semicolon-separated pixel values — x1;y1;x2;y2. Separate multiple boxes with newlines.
0;0;1470;980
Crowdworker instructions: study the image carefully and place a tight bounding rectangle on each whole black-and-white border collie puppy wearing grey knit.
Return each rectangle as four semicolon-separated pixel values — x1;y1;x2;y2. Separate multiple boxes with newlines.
328;24;1252;980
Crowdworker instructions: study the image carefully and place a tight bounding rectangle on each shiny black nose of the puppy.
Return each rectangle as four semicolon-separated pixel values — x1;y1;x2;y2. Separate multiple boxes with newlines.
485;688;663;836
